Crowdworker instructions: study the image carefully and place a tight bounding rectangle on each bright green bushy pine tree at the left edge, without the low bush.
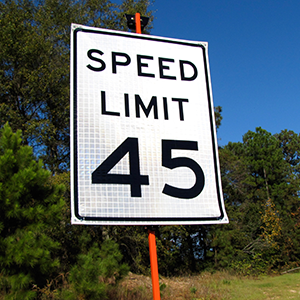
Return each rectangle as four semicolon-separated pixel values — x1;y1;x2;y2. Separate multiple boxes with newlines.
0;124;64;299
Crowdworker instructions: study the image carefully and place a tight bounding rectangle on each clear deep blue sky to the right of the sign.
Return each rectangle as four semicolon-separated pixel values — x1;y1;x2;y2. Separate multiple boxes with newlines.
151;0;300;146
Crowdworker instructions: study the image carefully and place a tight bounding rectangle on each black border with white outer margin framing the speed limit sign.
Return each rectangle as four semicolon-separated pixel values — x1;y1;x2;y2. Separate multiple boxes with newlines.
71;25;224;225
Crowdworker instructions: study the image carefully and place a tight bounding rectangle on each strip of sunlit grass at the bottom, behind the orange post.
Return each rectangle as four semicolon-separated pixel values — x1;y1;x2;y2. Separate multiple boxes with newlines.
115;272;300;300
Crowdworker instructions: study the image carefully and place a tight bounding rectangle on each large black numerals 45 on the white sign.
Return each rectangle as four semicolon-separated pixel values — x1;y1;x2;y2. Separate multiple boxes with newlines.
92;138;204;199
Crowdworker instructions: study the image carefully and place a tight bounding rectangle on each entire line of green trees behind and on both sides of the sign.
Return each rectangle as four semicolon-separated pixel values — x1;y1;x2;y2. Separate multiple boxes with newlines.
0;0;300;299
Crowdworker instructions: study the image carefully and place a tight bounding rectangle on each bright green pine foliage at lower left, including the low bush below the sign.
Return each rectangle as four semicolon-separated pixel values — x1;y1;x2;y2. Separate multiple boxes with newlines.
0;124;128;299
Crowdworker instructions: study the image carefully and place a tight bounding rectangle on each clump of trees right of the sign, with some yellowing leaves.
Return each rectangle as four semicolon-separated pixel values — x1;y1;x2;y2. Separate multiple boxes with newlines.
209;128;300;272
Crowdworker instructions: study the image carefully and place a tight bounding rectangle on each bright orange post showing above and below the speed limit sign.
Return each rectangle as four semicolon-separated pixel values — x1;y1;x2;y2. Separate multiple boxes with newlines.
130;13;160;300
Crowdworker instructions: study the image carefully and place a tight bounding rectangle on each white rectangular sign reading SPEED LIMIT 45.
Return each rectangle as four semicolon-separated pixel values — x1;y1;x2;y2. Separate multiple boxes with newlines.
71;24;228;225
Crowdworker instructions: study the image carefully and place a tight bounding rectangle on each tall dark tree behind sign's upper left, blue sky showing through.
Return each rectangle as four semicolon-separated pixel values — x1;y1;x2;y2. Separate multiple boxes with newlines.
0;0;153;173
